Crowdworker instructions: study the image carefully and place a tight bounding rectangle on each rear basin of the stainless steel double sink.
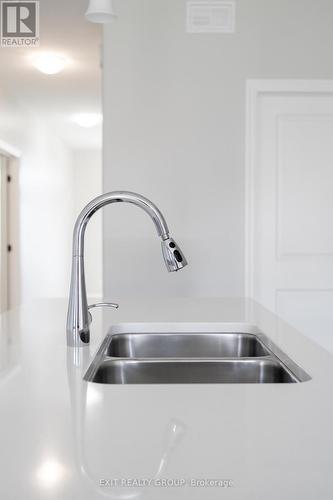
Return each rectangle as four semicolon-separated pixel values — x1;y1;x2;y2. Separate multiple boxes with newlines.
106;333;269;358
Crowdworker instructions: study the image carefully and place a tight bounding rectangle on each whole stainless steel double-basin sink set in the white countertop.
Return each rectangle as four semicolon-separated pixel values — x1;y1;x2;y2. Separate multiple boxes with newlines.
84;332;310;384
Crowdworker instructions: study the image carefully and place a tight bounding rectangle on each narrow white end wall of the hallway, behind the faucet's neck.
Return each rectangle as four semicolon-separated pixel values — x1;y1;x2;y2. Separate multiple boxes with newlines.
73;150;103;298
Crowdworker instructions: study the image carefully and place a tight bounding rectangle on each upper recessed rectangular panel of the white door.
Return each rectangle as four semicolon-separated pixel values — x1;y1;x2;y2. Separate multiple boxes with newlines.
276;114;333;259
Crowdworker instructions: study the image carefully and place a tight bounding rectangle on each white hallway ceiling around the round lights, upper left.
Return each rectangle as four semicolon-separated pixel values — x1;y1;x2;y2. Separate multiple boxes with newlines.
0;0;102;149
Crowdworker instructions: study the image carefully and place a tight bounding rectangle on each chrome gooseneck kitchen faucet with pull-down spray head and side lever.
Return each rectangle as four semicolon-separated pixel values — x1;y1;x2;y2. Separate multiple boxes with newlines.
67;191;187;347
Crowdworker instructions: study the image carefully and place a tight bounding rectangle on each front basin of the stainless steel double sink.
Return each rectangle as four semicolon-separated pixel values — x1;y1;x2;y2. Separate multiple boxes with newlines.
87;359;297;384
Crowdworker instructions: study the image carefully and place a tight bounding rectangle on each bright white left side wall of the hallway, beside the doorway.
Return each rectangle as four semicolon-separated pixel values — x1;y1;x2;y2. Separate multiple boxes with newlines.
0;89;73;303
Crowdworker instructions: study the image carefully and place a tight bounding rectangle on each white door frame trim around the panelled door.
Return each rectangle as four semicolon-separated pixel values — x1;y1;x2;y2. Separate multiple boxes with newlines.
245;79;333;298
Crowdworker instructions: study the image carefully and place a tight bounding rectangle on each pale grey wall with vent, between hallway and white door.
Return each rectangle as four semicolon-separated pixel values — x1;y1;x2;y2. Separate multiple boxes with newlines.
104;0;333;299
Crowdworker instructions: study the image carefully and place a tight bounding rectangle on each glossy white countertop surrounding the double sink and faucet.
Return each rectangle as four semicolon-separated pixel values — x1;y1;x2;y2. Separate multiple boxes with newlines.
0;299;333;500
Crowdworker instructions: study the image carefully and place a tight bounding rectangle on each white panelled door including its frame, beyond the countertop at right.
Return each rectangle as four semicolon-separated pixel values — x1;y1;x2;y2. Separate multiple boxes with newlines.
246;81;333;351
